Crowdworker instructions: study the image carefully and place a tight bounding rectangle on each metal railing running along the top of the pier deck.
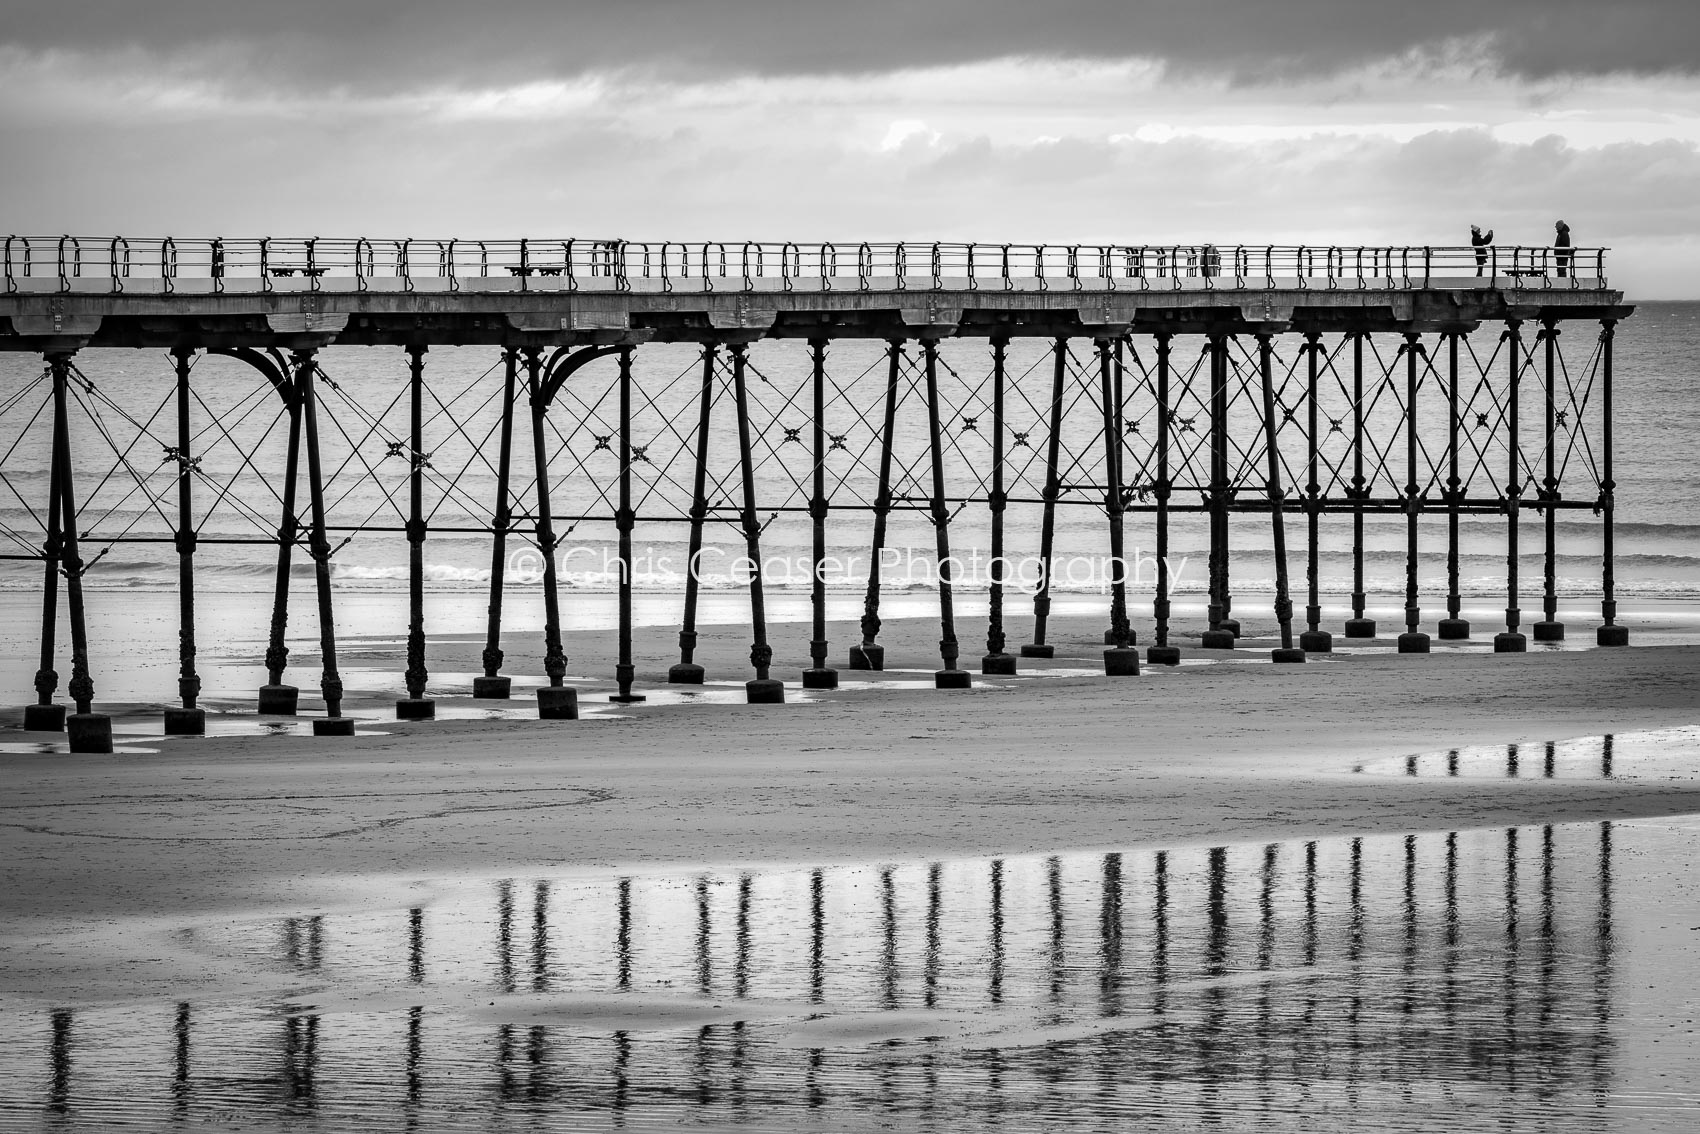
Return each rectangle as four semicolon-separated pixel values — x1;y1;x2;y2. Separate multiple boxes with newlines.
3;236;1607;294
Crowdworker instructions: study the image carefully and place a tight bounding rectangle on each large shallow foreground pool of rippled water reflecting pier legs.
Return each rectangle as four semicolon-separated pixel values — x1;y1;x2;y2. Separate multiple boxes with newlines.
0;799;1700;1131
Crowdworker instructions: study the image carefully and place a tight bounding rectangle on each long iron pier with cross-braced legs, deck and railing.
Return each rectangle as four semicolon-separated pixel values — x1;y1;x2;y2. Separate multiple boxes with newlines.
0;236;1632;750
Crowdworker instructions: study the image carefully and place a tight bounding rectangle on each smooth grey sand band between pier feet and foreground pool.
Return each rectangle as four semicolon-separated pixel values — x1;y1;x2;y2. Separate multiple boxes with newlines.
0;617;1700;972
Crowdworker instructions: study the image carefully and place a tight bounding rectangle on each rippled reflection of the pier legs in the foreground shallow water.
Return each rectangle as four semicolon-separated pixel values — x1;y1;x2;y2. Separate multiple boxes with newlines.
19;823;1617;1129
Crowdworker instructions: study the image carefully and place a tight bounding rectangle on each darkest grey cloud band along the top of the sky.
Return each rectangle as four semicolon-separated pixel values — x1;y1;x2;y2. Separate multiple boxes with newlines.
0;0;1700;88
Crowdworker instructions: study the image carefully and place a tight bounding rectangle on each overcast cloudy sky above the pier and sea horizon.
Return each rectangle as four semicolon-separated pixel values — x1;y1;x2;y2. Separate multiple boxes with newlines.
0;0;1700;299
